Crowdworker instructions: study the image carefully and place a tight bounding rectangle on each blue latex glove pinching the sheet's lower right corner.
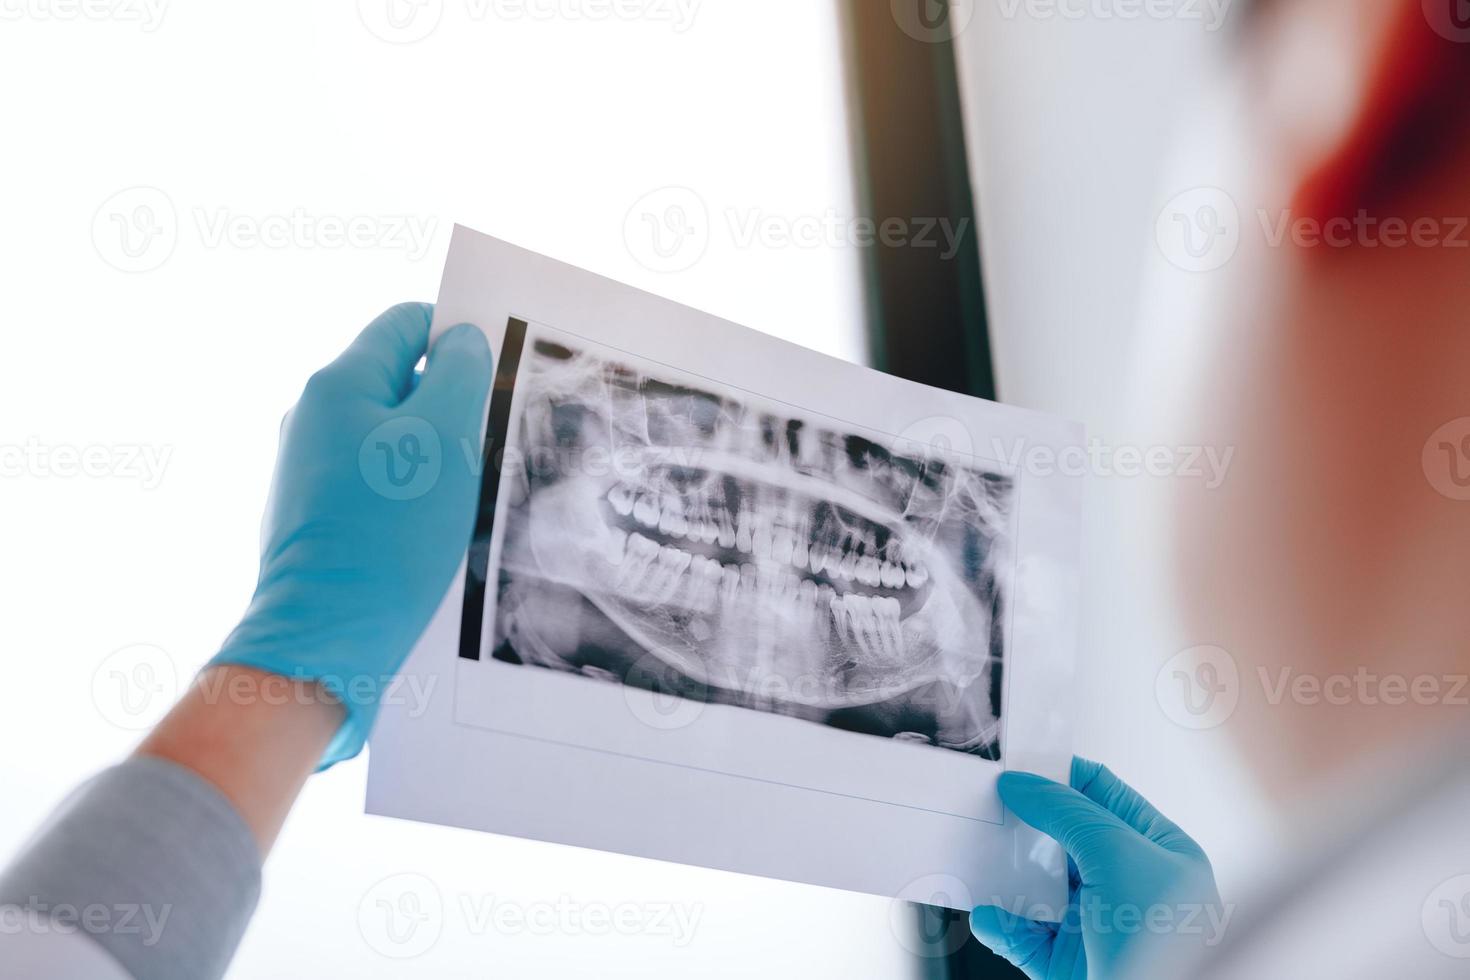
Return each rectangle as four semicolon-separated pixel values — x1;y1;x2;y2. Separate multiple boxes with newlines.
970;758;1229;980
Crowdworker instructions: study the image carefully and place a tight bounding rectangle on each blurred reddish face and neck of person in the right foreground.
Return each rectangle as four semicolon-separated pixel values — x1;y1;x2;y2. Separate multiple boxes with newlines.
1177;0;1470;795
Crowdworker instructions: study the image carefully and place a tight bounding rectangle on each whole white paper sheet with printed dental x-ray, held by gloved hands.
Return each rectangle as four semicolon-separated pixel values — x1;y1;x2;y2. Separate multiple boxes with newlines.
369;229;1082;909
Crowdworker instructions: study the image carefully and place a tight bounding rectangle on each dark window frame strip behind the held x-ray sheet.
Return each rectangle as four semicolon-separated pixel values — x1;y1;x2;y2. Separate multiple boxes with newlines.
841;0;1023;980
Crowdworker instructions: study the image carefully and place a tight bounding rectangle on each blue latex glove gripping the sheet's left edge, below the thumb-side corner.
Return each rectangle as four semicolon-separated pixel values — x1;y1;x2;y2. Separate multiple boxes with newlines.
212;303;491;768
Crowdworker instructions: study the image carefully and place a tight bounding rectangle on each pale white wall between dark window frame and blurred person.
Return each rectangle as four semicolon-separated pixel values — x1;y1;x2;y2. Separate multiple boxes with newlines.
957;0;1269;898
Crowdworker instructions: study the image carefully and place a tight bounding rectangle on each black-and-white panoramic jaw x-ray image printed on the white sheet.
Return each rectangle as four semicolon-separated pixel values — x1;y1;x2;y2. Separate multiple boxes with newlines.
494;341;1013;760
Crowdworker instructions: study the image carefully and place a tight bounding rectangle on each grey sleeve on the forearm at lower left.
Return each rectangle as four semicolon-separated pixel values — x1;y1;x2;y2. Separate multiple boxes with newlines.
0;758;260;980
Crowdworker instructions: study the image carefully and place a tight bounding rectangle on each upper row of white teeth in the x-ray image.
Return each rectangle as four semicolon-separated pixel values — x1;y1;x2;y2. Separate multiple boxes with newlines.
607;483;929;589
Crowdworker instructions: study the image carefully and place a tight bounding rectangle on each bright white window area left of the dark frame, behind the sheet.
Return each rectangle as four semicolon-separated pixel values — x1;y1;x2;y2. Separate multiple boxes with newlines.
0;0;929;979
